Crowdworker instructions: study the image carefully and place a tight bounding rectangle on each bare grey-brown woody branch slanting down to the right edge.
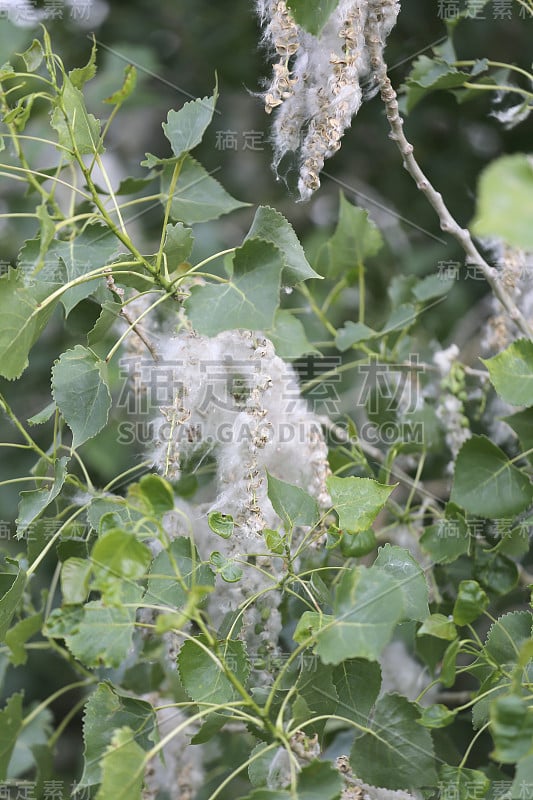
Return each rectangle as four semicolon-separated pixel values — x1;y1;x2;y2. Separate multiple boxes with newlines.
367;0;533;339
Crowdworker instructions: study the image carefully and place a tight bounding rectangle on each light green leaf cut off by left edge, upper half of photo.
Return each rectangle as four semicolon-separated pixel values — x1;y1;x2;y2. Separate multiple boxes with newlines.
0;269;58;380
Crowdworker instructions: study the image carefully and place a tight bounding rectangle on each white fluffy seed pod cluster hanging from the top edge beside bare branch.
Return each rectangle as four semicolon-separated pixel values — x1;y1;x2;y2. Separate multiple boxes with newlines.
258;0;399;200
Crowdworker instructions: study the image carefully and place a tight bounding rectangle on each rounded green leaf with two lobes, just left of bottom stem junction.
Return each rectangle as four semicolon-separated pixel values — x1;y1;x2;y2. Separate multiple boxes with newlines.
178;636;250;703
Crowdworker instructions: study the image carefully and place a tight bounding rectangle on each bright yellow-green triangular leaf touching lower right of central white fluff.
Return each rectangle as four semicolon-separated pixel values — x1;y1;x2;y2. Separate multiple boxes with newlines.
327;476;397;533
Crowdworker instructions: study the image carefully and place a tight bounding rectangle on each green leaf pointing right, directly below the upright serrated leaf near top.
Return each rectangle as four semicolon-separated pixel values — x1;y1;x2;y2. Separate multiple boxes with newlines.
161;156;249;225
